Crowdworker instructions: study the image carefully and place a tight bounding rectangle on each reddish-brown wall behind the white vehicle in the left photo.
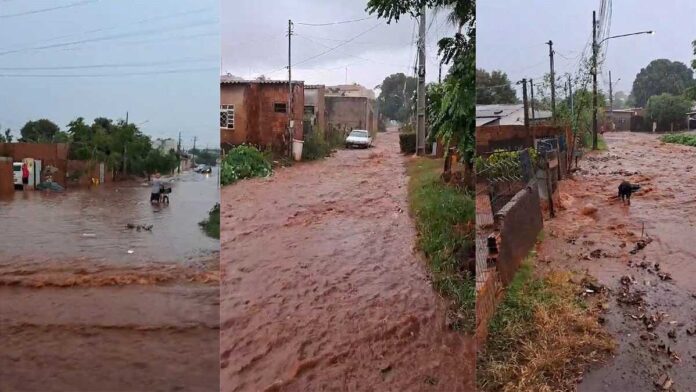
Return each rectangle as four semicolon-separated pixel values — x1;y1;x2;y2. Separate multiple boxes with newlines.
0;143;68;186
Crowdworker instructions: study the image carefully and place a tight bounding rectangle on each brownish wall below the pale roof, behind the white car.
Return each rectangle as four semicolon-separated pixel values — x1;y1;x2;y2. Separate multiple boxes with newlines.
325;96;377;135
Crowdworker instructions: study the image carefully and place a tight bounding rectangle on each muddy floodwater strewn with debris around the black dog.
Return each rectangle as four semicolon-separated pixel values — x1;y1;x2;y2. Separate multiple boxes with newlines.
539;133;696;392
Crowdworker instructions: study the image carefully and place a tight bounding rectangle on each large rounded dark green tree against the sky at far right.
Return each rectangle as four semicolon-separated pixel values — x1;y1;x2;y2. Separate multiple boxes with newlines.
632;59;696;106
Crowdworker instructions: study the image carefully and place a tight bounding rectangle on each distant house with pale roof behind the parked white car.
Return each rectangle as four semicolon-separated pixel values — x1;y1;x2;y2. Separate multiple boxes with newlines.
325;84;379;135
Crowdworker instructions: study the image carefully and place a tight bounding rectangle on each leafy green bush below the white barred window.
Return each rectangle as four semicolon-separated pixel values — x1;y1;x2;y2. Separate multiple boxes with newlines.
220;145;273;185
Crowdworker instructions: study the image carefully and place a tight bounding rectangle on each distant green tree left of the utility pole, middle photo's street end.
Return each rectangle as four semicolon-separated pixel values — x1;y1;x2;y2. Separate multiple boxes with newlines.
377;73;418;122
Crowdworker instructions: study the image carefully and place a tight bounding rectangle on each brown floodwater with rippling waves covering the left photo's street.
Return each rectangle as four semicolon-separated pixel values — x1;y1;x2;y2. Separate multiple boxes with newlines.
0;169;219;392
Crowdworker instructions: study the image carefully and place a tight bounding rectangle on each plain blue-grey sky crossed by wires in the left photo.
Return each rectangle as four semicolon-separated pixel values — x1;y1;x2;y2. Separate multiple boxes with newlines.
0;0;220;147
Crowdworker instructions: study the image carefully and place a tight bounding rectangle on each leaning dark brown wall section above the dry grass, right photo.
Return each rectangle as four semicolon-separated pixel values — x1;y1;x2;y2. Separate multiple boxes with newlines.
495;181;544;285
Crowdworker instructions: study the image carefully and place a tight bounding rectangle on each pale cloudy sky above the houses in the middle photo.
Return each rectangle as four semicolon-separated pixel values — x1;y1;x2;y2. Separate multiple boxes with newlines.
221;0;454;88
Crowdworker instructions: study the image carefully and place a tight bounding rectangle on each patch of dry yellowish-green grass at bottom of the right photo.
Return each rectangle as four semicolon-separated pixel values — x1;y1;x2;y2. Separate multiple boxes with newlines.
476;257;614;392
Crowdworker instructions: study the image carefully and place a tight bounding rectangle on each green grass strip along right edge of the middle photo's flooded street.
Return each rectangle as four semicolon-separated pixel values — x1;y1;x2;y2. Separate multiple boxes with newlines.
408;158;476;332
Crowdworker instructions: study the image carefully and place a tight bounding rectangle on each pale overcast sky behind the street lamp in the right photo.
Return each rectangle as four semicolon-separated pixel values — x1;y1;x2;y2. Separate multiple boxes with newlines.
476;0;696;98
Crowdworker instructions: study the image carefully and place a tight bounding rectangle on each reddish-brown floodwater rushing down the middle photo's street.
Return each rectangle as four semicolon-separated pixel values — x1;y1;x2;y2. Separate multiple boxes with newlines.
221;131;475;392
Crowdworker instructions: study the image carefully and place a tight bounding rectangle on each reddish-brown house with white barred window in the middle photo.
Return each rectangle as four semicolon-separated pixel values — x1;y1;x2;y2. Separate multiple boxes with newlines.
220;75;304;151
